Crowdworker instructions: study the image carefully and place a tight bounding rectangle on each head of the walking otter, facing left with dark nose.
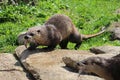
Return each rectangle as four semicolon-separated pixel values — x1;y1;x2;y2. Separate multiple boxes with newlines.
24;25;48;46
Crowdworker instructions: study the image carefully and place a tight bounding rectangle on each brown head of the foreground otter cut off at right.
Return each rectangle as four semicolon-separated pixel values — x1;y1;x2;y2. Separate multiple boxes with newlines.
77;57;107;75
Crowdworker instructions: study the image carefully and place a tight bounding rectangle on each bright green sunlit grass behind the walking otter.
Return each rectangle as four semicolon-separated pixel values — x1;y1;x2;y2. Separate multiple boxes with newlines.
0;0;120;52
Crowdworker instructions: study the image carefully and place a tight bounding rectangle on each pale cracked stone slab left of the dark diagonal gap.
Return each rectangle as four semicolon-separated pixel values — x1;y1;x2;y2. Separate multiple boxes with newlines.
0;53;29;80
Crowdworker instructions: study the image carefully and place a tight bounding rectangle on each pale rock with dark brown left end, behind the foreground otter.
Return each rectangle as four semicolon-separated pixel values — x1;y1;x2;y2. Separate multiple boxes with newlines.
90;46;120;56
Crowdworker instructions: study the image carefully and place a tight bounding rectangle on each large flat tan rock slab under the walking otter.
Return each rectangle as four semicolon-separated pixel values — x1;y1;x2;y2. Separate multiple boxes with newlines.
16;46;104;80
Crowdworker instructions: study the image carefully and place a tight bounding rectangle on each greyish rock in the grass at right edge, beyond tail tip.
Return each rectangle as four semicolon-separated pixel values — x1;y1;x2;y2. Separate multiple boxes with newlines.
108;22;120;40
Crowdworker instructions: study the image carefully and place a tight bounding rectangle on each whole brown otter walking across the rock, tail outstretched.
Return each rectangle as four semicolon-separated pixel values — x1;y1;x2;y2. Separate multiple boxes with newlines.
18;14;105;49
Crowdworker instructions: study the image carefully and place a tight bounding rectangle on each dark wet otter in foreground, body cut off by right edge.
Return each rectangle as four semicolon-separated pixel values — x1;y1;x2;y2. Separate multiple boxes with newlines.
63;54;120;80
